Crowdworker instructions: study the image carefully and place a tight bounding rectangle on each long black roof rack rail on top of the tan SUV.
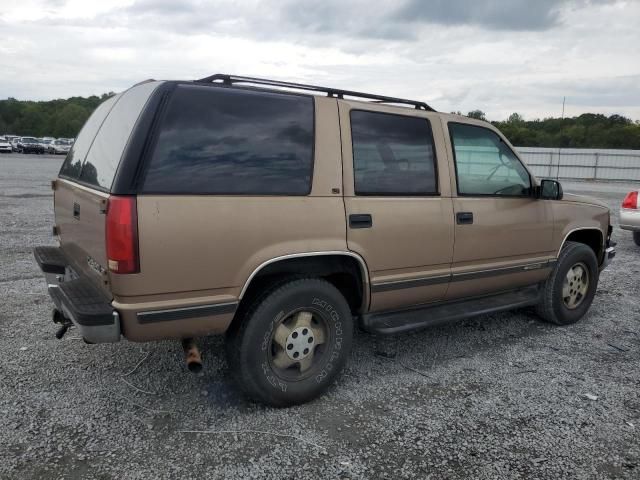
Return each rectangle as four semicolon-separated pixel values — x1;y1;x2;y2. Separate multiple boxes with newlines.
196;73;435;112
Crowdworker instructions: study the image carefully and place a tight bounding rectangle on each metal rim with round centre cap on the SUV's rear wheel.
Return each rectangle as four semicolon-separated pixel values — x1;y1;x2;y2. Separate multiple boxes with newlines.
270;310;329;380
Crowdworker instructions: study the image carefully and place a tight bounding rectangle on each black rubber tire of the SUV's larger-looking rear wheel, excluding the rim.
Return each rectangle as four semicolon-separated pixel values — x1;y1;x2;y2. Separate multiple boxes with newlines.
226;278;353;407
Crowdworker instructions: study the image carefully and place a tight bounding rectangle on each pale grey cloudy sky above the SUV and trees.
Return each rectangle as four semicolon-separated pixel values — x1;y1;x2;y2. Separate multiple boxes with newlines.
0;0;640;119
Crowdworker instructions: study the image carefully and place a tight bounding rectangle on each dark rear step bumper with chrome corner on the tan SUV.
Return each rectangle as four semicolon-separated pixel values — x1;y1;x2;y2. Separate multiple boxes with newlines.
33;247;121;343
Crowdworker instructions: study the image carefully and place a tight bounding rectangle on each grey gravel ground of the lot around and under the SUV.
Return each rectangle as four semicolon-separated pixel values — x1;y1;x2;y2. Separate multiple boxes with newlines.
0;155;640;479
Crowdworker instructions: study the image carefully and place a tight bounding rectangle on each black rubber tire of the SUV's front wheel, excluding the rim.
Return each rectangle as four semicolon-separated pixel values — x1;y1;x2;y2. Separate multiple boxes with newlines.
536;242;599;325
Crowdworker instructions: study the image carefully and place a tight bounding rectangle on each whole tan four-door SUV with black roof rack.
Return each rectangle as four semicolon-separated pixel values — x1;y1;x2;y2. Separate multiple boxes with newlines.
35;75;615;406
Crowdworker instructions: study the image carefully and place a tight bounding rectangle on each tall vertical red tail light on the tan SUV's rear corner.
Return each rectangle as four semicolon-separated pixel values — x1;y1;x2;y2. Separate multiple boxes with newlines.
106;196;140;273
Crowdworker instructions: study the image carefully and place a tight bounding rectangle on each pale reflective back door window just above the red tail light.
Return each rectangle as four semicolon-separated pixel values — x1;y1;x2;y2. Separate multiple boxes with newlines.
80;82;160;190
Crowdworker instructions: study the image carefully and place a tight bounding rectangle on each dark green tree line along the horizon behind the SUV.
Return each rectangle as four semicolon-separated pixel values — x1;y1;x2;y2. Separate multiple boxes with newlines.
0;92;640;149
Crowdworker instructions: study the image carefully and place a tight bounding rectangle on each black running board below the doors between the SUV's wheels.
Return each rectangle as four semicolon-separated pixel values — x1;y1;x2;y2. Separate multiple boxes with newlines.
361;285;541;335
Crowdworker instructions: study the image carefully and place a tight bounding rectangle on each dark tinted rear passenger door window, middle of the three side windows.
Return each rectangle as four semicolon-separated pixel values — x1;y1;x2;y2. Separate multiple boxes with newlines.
351;110;438;196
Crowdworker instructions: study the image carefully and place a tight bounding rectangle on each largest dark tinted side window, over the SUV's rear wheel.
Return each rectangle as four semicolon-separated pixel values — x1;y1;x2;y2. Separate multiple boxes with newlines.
144;85;314;195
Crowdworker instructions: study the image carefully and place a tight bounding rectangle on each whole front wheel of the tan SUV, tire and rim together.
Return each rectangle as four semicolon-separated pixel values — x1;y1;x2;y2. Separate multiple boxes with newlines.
538;242;599;325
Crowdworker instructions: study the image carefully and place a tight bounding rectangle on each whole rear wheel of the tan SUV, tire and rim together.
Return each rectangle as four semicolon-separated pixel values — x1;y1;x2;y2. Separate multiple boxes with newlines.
227;278;353;407
